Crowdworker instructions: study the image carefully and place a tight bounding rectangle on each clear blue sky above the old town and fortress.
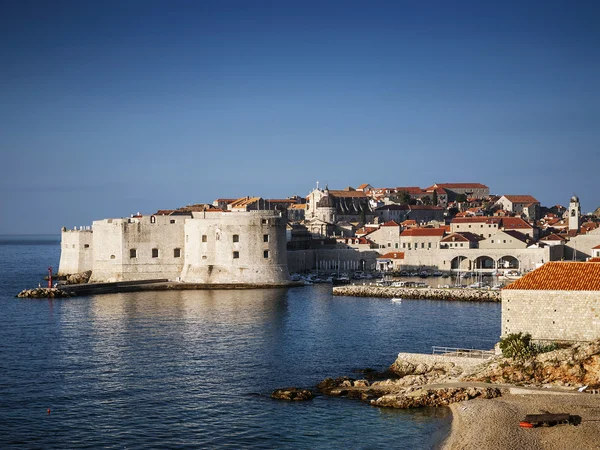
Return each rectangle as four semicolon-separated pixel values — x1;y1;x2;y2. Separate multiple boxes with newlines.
0;0;600;234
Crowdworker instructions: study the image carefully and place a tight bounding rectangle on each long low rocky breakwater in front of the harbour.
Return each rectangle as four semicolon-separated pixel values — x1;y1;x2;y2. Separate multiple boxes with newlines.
333;285;501;302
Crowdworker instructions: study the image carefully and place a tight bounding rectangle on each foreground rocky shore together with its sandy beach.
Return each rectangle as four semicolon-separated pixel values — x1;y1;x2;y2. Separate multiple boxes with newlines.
274;341;600;450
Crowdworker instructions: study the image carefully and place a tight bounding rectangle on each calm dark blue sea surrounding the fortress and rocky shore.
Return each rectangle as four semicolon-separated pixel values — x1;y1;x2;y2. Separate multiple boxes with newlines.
0;236;500;449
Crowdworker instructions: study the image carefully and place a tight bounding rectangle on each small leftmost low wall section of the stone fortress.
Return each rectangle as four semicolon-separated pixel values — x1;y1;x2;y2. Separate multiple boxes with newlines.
58;228;94;275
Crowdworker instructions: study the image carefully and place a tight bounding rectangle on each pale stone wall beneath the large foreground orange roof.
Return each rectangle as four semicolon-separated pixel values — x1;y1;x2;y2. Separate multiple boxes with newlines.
502;289;600;341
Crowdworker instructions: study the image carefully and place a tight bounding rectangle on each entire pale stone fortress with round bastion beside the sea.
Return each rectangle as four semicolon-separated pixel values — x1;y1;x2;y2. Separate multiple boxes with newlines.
59;210;289;285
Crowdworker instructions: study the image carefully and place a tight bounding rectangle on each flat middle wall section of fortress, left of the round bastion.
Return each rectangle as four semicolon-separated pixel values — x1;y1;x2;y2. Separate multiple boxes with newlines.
91;216;186;282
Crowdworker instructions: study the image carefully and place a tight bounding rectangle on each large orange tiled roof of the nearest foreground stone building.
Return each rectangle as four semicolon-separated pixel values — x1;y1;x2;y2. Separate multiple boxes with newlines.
504;261;600;291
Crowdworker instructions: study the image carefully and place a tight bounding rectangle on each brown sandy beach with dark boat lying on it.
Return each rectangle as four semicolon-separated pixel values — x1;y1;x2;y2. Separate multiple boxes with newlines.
442;390;600;450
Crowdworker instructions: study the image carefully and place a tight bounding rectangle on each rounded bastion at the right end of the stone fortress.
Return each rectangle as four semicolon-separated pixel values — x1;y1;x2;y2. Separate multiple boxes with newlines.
181;211;289;284
